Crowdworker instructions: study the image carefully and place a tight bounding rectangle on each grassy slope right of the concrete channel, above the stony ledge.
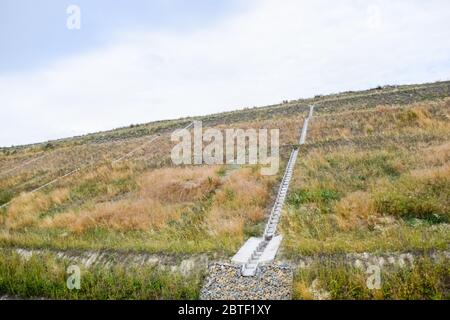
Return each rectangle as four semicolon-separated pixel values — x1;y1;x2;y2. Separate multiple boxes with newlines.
280;99;450;255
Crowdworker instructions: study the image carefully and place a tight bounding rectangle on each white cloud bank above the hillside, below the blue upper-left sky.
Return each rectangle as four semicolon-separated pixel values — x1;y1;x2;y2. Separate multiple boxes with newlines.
0;0;450;145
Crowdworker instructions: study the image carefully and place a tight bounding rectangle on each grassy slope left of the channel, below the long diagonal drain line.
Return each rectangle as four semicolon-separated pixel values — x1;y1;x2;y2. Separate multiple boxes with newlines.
0;166;273;254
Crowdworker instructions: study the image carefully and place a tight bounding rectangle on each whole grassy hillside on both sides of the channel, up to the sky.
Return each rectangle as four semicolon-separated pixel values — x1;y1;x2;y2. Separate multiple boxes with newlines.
0;82;450;297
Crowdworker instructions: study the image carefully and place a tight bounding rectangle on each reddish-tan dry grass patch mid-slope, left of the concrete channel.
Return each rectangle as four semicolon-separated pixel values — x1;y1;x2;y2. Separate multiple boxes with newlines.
40;167;220;233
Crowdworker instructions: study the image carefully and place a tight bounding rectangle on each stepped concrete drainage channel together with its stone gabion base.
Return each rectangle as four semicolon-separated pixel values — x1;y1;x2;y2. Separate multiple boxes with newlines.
200;106;314;300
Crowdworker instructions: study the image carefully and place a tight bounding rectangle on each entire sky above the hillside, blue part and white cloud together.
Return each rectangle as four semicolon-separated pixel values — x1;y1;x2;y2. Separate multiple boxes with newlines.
0;0;450;146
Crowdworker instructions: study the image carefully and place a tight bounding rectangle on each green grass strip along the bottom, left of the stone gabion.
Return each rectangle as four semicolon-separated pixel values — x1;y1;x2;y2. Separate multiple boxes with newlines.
0;251;203;300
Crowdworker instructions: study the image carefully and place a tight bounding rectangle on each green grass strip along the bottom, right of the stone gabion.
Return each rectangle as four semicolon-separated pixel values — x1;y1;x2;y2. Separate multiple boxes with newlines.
294;258;450;300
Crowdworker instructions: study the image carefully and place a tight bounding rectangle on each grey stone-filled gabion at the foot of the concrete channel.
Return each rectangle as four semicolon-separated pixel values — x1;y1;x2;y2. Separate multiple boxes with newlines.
200;262;293;300
